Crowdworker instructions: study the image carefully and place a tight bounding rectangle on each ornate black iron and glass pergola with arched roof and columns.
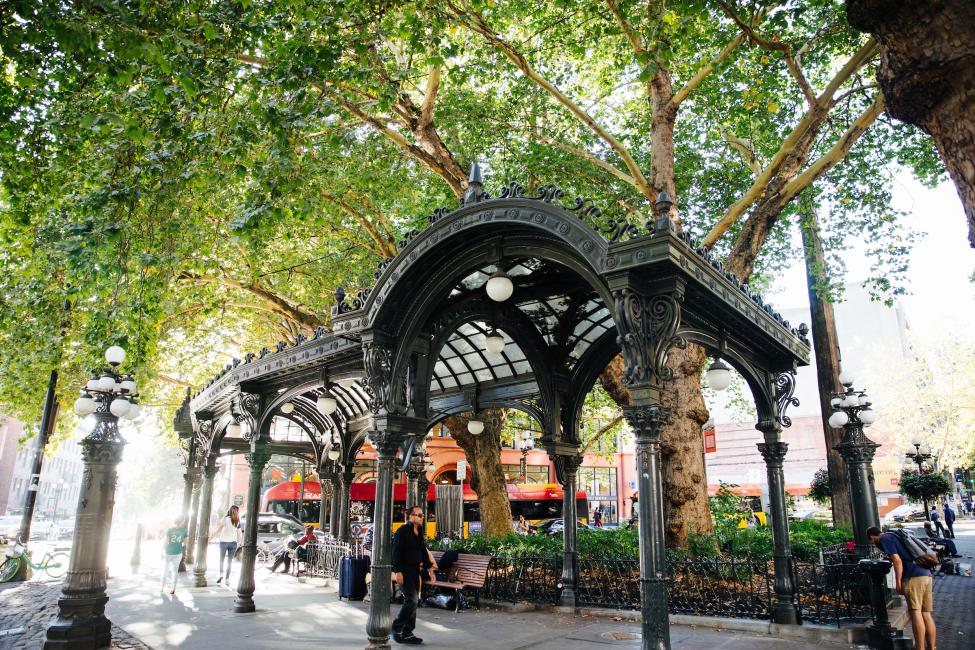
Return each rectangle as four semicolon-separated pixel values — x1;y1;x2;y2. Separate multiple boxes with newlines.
177;166;809;648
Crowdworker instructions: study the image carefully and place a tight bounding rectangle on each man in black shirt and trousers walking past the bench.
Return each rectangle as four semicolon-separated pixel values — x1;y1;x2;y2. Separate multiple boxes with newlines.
393;508;433;645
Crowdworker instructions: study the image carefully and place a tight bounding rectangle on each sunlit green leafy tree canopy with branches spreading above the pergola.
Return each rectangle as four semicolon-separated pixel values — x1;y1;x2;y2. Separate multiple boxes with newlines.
0;0;943;440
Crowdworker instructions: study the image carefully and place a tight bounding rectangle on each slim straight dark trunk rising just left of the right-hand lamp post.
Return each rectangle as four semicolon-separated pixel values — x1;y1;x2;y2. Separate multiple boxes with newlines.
801;212;853;530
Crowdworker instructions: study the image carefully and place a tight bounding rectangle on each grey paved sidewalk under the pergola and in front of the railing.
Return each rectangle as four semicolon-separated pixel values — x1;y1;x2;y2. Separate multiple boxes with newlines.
101;569;853;650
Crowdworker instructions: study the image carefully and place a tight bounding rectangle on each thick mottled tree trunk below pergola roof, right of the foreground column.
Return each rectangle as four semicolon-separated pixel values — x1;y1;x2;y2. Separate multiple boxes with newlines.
660;345;714;548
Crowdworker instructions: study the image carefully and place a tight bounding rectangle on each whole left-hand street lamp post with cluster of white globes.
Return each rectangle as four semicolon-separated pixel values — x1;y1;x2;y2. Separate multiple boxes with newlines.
44;345;139;650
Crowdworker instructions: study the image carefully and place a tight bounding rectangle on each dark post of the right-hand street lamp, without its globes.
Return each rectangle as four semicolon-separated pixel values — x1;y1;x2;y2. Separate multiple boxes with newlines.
836;418;880;558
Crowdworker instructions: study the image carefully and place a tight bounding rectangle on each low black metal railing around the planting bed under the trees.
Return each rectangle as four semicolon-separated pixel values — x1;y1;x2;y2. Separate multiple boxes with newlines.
481;553;871;626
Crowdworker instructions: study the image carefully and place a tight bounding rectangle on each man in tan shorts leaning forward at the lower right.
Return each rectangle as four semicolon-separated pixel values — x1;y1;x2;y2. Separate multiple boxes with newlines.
867;526;938;650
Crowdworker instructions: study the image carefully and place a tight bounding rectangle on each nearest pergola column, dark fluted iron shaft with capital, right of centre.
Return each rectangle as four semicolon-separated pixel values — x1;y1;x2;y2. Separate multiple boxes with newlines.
623;404;670;650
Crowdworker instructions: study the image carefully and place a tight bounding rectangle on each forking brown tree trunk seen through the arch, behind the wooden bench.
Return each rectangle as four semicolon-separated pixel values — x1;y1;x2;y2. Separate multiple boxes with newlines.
444;409;511;537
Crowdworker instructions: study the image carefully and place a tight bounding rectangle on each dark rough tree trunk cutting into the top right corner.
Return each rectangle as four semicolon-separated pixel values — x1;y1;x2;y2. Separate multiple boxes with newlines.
846;0;975;247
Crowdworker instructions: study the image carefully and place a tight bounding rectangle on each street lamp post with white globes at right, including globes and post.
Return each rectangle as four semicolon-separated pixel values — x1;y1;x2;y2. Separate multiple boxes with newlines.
829;371;880;557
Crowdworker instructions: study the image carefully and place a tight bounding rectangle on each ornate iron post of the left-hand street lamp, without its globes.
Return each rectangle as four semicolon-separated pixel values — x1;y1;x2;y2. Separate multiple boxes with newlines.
44;402;125;650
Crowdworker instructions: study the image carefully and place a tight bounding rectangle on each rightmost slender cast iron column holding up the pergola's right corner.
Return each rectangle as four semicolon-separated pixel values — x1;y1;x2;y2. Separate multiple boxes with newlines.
755;420;799;625
